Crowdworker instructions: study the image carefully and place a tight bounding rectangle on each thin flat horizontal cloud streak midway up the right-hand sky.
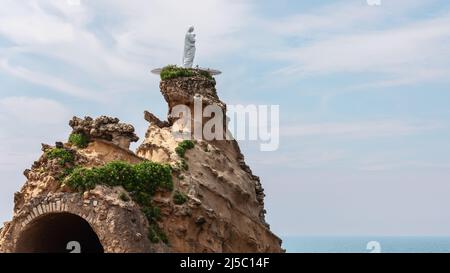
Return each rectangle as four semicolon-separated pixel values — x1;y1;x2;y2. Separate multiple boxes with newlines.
280;120;444;138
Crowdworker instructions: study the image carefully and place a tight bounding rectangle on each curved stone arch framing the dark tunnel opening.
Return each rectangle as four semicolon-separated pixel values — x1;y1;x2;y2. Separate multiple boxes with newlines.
0;189;156;253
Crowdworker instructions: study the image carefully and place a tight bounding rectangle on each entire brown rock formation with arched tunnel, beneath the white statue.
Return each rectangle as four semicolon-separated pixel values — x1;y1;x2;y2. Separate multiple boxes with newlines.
0;69;283;252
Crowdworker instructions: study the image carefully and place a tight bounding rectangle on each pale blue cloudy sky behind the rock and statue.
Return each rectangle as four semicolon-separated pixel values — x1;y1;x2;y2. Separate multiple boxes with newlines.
0;0;450;237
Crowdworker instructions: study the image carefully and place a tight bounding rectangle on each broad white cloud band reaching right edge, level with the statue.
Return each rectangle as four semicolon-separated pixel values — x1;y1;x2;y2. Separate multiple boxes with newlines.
272;17;450;73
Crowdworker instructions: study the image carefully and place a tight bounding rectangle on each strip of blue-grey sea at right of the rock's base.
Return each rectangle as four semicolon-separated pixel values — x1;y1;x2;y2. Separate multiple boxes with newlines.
282;236;450;253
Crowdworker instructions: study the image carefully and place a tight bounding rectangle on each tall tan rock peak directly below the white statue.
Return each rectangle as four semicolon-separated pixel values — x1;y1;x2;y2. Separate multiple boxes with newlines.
137;76;282;252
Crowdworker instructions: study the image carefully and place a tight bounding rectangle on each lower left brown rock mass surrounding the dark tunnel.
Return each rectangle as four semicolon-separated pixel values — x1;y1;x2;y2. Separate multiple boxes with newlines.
0;139;160;253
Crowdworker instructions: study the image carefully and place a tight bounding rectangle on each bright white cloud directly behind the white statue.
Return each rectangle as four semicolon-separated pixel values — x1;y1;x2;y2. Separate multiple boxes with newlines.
106;0;252;60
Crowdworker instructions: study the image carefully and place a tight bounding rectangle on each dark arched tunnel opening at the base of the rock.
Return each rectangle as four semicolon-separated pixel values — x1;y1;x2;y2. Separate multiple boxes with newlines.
16;213;103;253
